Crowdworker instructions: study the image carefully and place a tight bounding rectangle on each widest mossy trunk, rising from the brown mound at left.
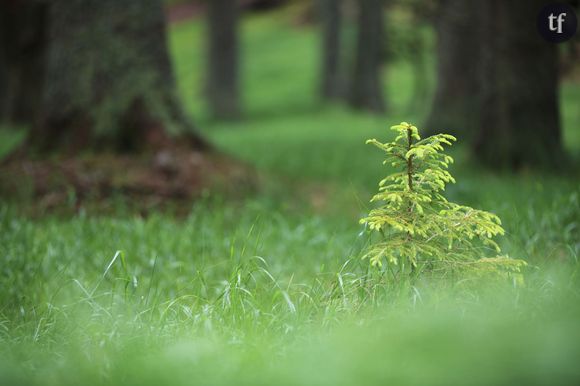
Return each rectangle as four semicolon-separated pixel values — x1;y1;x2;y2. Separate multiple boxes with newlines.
27;0;205;152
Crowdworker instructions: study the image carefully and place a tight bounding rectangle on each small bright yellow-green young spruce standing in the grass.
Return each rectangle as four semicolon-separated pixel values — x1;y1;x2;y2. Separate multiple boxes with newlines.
361;122;526;276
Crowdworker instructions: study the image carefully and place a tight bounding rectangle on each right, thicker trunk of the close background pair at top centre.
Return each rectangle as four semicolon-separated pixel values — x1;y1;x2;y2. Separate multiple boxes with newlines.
349;0;385;112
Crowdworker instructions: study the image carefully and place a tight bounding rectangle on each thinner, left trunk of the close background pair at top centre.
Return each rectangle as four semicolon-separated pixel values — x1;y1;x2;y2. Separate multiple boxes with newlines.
319;0;342;100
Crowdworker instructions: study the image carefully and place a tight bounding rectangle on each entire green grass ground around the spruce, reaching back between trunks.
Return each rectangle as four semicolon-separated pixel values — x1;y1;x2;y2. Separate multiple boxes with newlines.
0;9;580;385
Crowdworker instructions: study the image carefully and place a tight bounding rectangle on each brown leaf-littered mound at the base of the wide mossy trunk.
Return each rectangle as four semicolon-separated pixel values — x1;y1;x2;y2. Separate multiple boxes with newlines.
0;148;258;214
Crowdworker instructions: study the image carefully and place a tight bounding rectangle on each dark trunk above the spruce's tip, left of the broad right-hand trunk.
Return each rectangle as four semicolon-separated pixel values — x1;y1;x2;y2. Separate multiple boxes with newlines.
425;0;487;136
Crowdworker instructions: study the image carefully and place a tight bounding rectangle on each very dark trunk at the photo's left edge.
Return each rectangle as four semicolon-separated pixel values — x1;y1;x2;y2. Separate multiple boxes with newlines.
0;0;46;124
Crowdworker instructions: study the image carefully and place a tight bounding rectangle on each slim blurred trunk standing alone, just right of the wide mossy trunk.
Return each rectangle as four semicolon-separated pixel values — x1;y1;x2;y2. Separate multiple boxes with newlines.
207;0;240;119
